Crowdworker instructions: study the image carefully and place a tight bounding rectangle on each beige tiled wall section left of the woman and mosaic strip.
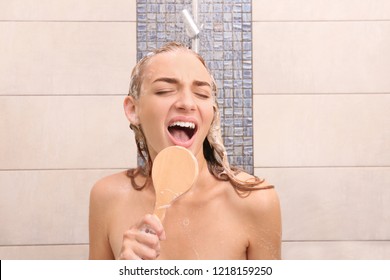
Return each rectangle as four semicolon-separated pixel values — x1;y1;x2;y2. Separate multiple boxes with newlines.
0;0;136;259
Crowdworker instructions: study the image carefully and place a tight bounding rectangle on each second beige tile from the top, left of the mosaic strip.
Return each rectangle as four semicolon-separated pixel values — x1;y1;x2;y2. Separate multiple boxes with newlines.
0;21;136;95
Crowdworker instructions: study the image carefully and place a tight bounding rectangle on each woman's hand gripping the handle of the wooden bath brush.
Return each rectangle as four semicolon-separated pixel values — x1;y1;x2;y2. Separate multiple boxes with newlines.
119;214;166;260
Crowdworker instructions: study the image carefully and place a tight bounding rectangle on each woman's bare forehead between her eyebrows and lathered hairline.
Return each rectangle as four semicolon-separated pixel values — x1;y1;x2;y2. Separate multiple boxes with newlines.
143;50;211;82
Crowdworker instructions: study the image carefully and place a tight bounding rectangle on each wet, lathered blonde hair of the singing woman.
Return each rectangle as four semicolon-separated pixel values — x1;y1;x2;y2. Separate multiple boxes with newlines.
127;42;273;192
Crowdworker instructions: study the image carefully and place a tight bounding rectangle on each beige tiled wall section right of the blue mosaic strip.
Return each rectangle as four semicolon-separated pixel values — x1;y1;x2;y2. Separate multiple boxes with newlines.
252;0;390;259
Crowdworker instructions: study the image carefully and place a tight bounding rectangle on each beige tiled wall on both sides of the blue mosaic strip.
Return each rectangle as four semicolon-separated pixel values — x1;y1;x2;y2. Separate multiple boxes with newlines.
0;0;390;259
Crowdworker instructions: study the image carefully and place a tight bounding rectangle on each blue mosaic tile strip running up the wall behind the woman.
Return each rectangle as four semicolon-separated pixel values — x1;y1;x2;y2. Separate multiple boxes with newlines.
137;0;253;173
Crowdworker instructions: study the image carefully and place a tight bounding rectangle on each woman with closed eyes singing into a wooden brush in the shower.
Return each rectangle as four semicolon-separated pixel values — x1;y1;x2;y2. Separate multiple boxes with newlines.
89;43;281;259
